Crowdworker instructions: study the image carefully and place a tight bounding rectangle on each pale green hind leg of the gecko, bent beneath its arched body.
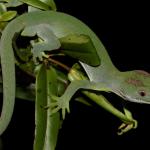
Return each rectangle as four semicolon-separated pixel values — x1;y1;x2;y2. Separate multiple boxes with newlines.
21;23;60;62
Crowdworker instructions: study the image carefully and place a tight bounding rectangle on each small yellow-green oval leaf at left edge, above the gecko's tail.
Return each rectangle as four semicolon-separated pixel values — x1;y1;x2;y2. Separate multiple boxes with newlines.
0;11;17;21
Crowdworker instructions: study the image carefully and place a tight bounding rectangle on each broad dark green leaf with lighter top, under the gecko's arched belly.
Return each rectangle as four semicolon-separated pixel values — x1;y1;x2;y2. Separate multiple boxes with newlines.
60;34;100;66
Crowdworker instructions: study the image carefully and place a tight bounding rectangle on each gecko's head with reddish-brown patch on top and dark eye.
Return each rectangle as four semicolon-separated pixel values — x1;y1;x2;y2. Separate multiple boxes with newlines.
116;70;150;104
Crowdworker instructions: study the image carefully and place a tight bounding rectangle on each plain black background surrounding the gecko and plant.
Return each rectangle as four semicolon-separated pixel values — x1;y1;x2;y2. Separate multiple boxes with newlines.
2;0;150;150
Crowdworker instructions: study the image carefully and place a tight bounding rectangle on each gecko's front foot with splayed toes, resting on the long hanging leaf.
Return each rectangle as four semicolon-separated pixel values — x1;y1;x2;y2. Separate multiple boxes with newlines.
50;96;70;119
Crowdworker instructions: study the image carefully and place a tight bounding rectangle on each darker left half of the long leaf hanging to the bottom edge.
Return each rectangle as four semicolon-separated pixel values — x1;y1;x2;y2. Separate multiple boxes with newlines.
34;66;47;150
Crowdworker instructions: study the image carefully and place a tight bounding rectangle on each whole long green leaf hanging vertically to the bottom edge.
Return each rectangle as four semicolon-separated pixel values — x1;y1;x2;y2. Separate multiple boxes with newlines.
34;65;60;150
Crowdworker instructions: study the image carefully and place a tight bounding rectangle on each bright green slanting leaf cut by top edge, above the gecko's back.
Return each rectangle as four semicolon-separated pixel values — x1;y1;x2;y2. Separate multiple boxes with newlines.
20;0;51;10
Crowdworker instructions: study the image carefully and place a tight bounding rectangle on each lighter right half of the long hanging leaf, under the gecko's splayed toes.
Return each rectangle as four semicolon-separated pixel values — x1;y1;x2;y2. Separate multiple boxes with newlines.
44;65;60;150
